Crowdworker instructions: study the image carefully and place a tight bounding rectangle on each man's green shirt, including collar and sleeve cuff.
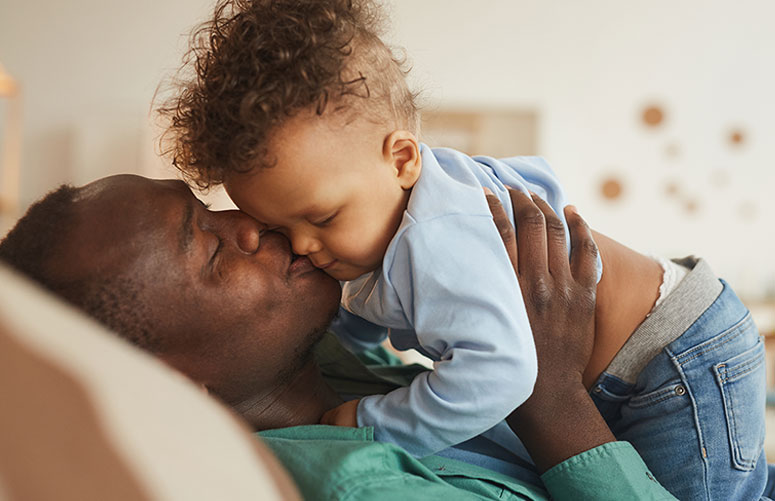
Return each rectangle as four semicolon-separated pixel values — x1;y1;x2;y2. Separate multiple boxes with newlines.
259;336;675;501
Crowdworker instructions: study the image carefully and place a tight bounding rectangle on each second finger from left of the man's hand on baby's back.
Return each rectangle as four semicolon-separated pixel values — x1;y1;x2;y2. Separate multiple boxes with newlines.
509;189;548;276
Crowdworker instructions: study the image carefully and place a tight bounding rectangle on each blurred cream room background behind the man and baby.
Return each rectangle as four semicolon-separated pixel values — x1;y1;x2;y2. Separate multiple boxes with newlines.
0;0;775;430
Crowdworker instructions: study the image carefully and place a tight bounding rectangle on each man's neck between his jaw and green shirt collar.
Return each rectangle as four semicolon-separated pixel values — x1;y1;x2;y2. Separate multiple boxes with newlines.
232;361;342;431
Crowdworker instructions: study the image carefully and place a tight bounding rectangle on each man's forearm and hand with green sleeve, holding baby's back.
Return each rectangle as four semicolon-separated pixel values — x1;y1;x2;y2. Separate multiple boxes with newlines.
487;191;674;500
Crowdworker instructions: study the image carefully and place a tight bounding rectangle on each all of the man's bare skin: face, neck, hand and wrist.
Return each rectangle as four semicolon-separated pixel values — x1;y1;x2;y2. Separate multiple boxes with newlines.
45;176;613;469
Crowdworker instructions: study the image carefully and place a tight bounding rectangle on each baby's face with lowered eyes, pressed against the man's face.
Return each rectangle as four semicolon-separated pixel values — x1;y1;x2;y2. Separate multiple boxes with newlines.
225;114;409;280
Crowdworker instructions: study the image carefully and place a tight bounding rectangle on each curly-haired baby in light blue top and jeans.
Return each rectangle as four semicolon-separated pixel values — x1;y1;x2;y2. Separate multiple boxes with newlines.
162;0;766;499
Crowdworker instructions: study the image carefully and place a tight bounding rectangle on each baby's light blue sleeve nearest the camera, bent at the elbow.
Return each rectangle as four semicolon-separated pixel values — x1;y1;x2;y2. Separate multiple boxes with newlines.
358;214;537;457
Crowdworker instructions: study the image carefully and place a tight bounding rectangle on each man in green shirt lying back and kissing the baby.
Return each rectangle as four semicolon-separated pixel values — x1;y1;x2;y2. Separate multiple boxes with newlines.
0;176;670;499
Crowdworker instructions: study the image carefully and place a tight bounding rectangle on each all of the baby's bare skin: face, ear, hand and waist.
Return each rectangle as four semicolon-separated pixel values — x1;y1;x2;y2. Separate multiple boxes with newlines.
226;112;662;388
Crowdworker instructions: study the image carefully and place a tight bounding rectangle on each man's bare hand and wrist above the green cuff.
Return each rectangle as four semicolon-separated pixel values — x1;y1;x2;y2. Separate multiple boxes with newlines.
487;190;615;472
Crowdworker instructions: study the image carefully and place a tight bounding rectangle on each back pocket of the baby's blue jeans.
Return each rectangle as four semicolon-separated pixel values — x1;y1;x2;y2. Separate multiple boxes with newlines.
713;337;766;471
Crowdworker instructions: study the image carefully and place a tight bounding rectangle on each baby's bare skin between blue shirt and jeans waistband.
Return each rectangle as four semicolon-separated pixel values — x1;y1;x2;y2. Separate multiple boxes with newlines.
584;231;662;388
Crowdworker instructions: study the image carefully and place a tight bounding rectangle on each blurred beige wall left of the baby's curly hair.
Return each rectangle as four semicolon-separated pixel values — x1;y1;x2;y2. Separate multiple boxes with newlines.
0;0;212;203
